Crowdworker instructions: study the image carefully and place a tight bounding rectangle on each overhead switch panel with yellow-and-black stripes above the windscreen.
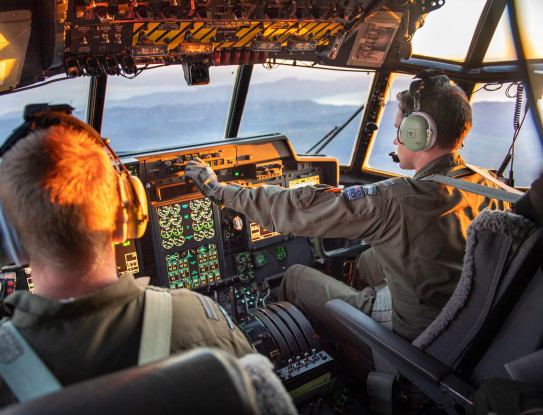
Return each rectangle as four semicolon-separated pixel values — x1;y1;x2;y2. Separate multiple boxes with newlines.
65;0;362;79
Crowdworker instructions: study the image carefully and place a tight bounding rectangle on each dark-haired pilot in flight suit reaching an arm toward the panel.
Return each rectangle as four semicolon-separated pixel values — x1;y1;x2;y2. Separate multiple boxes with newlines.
185;72;509;340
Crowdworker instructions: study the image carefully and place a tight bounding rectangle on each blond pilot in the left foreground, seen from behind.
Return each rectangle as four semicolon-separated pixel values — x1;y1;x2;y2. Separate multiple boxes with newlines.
0;107;254;405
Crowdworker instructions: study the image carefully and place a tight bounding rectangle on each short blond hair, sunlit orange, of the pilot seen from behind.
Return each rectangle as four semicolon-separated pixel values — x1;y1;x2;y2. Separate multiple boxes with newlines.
0;125;120;266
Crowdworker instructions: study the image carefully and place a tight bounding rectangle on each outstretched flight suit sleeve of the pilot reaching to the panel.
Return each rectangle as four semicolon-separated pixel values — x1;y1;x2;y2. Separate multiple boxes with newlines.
215;184;384;243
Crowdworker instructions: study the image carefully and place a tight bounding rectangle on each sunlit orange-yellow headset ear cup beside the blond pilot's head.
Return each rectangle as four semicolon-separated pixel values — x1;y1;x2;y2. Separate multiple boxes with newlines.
117;172;149;242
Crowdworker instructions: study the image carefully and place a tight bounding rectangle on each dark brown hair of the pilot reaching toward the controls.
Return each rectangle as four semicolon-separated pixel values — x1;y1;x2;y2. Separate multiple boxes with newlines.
397;75;472;150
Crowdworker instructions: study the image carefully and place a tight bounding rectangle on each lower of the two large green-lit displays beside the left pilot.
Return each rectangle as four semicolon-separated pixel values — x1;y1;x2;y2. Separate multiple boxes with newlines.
166;244;221;290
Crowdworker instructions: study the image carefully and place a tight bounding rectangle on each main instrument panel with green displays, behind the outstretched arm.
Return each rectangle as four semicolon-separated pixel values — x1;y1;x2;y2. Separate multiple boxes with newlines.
127;135;338;300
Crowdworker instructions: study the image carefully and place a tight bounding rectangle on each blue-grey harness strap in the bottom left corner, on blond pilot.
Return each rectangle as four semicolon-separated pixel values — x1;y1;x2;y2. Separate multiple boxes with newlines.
0;321;62;402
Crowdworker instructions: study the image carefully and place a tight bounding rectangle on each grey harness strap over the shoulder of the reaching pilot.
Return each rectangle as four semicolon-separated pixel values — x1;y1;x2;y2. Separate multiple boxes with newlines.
419;164;523;203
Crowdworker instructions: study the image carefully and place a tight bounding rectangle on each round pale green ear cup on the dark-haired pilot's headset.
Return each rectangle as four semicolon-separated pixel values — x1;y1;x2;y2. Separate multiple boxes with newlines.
399;112;437;152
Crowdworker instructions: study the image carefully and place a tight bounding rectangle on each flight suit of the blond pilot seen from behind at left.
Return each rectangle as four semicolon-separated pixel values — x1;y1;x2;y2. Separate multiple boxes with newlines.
0;274;254;406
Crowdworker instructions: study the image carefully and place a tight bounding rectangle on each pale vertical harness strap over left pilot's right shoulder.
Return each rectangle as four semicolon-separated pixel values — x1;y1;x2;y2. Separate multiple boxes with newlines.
138;287;172;366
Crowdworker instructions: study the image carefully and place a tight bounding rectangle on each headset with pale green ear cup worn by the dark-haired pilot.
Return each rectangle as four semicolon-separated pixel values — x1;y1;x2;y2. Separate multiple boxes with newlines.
398;70;452;152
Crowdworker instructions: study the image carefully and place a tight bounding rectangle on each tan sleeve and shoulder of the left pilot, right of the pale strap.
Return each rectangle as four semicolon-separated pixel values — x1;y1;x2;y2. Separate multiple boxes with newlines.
171;289;255;357
